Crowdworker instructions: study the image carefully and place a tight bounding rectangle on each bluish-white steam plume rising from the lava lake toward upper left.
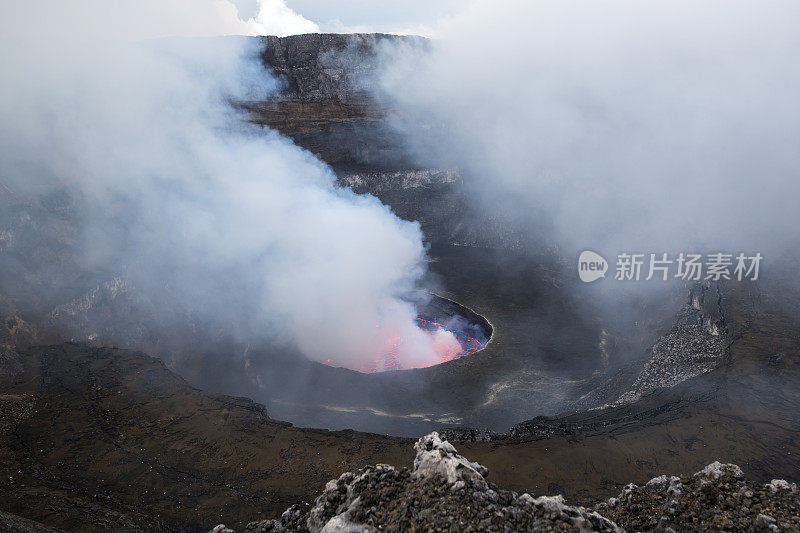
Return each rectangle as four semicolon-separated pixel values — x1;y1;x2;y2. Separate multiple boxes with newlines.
0;0;439;368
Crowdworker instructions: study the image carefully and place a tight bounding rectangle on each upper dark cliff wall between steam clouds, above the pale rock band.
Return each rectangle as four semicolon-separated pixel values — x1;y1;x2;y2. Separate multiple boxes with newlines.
246;34;424;169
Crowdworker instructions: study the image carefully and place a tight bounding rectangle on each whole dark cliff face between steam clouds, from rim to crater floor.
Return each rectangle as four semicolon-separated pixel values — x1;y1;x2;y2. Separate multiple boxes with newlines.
250;34;580;250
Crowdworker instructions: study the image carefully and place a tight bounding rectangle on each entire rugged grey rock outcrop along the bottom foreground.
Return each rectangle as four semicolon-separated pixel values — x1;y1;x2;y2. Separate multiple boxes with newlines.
213;433;800;533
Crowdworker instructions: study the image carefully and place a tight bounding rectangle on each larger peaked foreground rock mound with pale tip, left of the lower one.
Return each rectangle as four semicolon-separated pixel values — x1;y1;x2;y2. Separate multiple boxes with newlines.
236;433;620;533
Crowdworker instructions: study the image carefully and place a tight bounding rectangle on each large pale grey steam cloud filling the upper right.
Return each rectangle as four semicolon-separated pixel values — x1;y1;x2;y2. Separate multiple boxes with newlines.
382;0;800;257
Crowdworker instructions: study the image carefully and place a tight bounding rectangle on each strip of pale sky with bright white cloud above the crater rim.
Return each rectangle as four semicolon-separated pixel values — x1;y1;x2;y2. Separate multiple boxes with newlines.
0;0;464;41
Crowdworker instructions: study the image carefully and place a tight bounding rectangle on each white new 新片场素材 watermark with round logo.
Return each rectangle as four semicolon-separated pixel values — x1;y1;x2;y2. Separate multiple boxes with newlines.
578;250;764;283
